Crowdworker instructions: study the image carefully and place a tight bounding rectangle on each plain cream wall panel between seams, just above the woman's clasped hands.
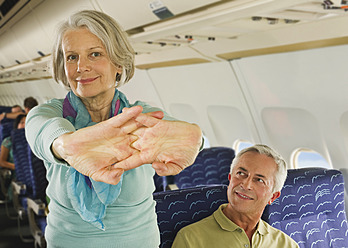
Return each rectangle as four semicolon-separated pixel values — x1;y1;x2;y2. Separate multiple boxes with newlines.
143;62;255;147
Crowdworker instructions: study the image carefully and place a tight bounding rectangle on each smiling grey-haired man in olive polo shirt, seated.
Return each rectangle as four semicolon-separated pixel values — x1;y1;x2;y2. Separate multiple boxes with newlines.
172;145;299;248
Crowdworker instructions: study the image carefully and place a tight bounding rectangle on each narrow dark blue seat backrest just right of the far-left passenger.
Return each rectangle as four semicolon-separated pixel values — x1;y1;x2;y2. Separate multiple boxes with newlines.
11;128;32;194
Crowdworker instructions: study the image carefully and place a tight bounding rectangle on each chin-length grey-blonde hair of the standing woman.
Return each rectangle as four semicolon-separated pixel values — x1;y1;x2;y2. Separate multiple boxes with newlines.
52;10;135;87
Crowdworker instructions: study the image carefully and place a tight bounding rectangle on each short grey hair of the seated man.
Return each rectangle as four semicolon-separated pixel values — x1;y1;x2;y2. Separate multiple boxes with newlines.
230;144;288;193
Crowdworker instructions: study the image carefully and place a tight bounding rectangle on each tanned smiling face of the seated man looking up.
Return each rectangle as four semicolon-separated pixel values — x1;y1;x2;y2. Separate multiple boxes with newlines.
228;151;280;214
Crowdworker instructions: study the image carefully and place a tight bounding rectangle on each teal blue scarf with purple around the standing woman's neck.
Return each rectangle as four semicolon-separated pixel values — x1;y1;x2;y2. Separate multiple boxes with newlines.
63;89;130;230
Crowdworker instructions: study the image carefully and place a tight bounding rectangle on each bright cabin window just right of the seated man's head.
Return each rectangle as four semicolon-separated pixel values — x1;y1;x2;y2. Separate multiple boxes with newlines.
291;148;331;169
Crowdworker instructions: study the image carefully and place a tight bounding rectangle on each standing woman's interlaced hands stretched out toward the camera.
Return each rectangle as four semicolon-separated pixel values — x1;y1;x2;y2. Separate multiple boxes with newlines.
52;106;202;184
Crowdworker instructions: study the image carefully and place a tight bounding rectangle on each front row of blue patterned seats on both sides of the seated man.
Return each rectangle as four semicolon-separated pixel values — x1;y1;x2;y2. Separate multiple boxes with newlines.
154;168;348;248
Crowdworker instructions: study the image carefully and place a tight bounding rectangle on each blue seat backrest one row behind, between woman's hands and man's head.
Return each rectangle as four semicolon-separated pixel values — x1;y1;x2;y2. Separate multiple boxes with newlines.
174;147;235;189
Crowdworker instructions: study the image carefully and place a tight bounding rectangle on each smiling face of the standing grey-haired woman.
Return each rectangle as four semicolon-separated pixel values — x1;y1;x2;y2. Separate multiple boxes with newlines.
62;28;122;98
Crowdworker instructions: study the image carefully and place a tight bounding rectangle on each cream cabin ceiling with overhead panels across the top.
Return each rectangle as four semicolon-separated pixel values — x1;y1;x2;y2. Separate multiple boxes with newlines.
0;0;348;82
